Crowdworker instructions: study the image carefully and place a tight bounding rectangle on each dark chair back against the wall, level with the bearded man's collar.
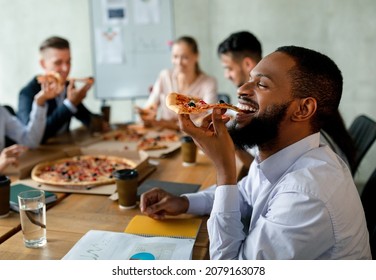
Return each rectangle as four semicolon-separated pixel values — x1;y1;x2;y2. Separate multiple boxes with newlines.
349;115;376;175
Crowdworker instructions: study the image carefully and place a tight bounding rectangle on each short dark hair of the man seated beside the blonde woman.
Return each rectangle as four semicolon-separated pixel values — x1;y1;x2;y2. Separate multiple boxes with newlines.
218;31;262;63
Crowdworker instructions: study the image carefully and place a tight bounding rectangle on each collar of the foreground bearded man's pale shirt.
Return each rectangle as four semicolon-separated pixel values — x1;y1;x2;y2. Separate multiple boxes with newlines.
255;132;320;184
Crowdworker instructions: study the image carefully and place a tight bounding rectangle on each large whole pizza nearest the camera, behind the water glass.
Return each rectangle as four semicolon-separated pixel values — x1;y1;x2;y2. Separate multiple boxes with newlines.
31;155;136;186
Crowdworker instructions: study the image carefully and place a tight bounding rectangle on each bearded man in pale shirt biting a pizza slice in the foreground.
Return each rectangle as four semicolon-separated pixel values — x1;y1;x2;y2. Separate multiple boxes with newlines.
140;46;371;260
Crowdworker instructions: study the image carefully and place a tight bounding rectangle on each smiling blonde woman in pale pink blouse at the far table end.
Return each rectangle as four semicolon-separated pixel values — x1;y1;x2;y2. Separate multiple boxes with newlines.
137;36;218;130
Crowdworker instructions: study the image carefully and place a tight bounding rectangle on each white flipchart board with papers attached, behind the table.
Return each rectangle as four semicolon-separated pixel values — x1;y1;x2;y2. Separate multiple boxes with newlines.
90;0;174;101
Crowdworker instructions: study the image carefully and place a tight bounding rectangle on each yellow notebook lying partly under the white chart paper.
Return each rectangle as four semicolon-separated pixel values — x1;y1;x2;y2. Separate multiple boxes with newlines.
124;215;201;239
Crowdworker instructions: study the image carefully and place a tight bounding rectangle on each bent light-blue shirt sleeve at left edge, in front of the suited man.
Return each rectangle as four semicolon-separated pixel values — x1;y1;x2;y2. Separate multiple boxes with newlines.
0;102;47;151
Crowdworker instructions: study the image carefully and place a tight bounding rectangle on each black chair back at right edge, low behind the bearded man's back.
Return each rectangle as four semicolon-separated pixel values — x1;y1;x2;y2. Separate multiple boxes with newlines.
360;168;376;259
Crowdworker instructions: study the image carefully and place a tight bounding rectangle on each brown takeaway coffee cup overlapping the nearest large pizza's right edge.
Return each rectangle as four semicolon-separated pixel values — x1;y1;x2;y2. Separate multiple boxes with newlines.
113;169;138;209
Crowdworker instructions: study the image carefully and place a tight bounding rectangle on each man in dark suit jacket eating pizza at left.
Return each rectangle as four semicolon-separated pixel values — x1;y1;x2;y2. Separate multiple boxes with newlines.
18;37;92;143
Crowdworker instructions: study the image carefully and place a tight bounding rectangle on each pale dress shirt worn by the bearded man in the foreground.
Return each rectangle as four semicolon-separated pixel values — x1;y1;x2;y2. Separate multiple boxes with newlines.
186;133;371;260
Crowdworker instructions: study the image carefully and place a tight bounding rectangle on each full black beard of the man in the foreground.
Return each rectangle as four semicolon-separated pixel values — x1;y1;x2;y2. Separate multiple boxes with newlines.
229;101;291;149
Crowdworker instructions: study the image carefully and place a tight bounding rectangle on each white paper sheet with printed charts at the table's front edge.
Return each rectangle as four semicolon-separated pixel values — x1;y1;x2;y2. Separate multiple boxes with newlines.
62;230;195;260
